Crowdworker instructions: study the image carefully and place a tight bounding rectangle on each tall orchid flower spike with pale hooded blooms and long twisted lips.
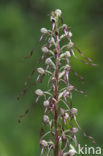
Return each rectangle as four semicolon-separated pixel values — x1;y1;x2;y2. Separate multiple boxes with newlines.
18;9;96;156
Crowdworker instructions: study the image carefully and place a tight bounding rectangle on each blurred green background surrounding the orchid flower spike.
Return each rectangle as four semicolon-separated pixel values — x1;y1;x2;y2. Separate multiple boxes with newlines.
0;0;103;156
